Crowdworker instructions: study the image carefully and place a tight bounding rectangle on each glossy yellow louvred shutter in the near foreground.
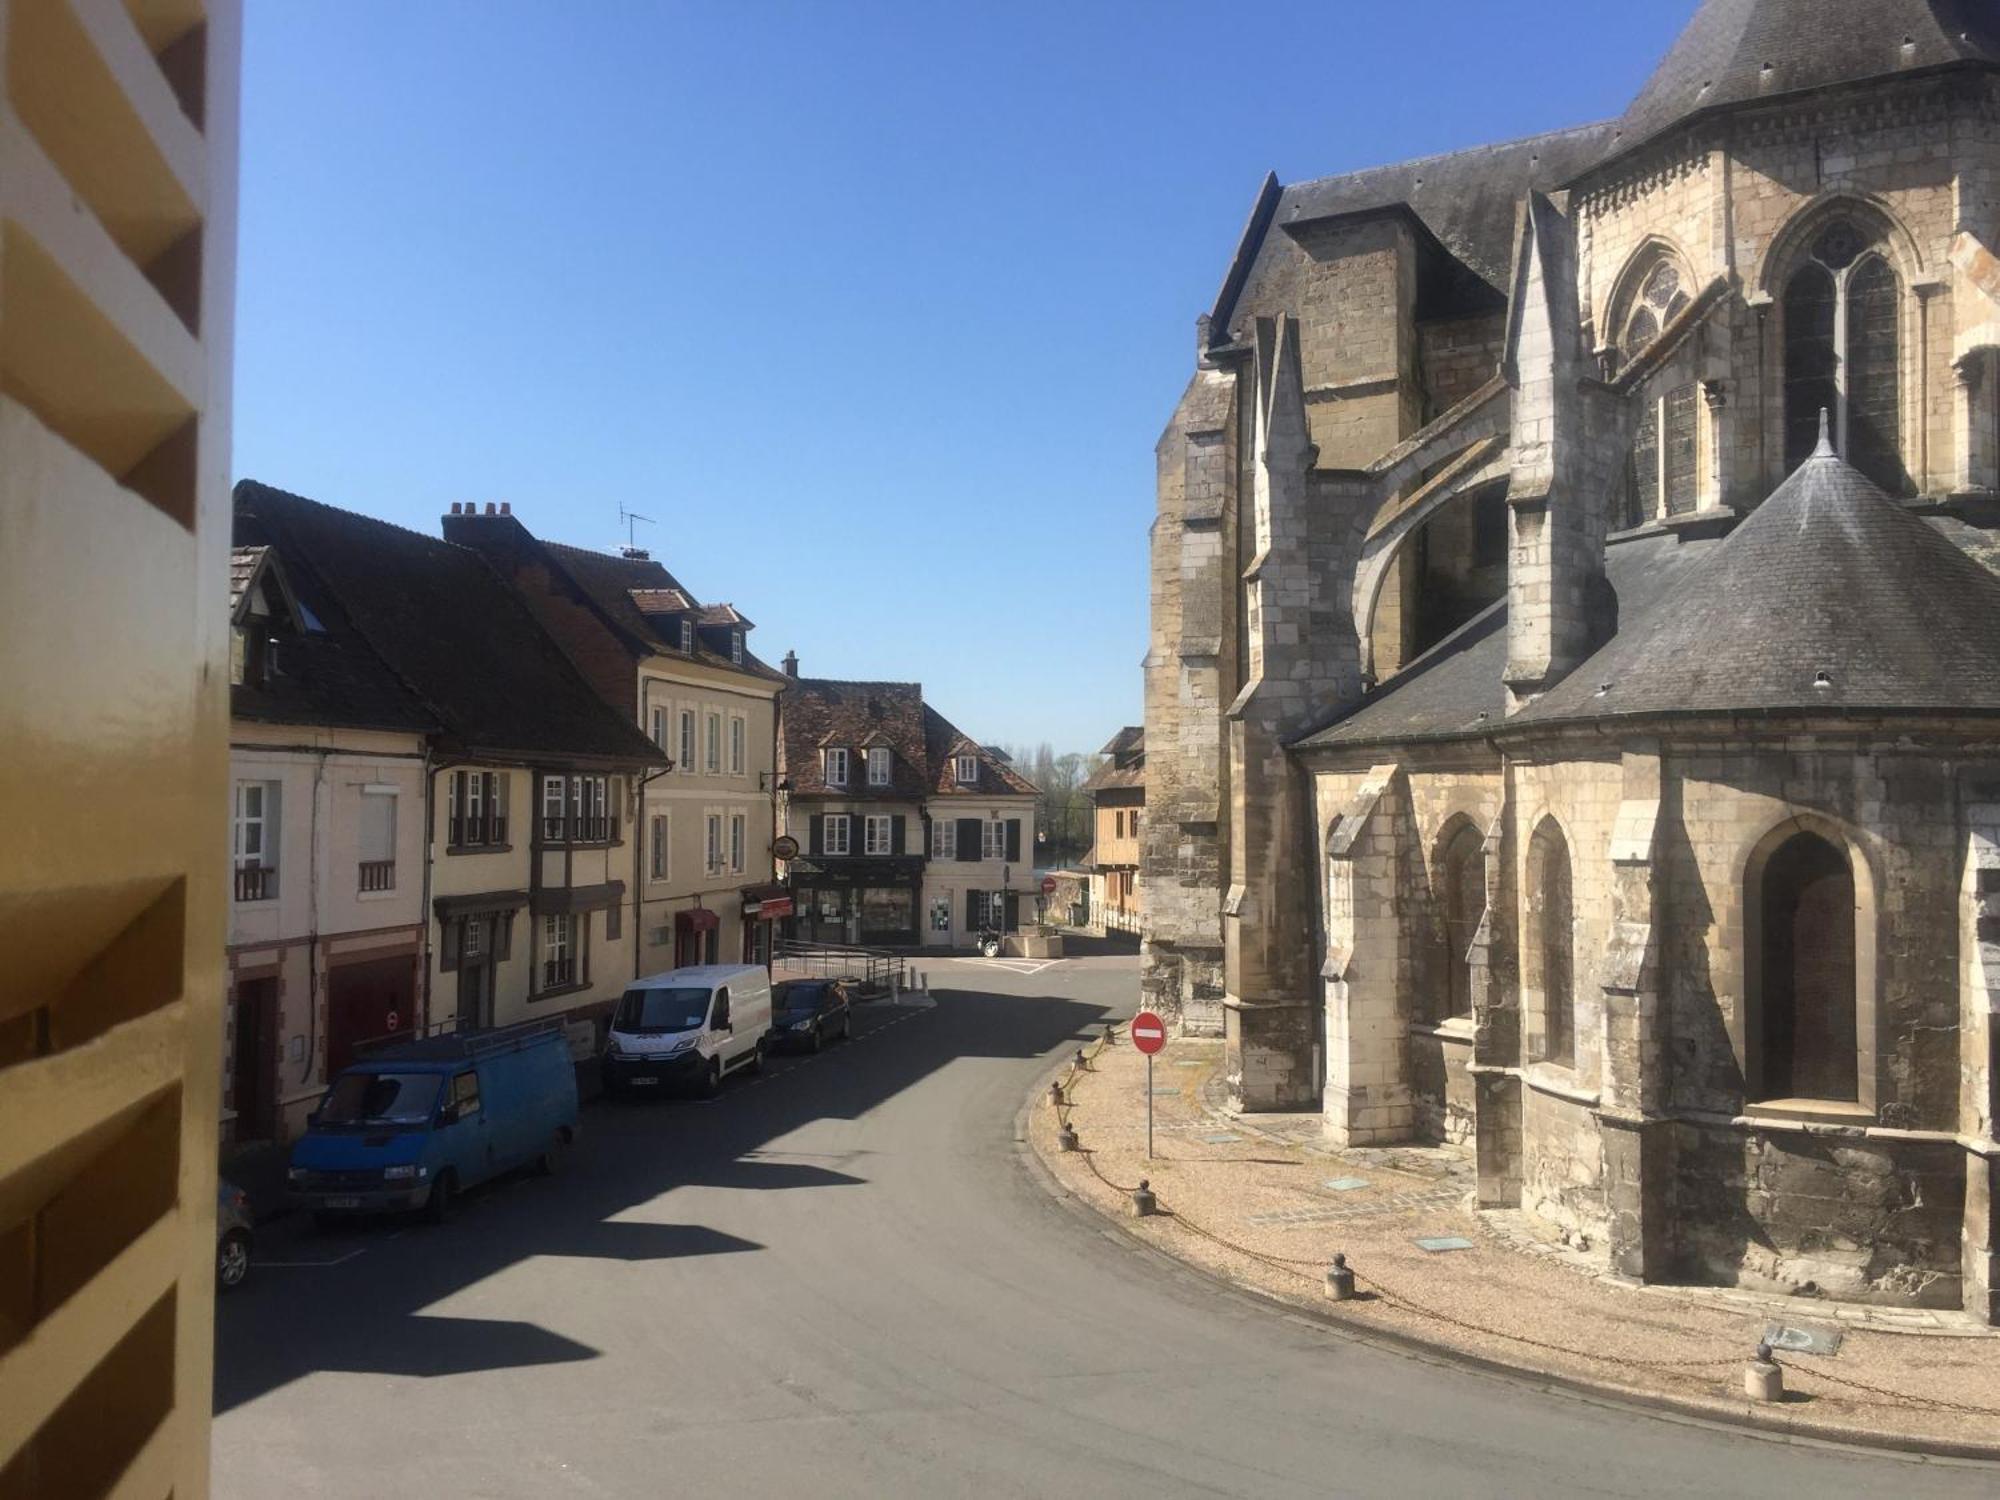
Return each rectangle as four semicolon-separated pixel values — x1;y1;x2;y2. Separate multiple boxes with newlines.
0;0;240;1496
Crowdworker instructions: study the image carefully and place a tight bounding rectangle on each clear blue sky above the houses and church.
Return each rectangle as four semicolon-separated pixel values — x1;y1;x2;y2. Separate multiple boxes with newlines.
236;0;1694;750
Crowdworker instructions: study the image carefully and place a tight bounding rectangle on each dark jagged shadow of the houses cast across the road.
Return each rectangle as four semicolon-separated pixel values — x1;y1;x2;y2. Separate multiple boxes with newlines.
214;990;1110;1414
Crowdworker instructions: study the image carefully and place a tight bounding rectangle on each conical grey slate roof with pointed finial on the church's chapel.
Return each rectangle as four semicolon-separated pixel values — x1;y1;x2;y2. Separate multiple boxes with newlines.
1512;420;2000;724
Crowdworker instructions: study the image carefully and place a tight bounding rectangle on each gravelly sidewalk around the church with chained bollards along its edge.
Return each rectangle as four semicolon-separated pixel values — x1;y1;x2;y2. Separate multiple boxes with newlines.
1028;1034;2000;1460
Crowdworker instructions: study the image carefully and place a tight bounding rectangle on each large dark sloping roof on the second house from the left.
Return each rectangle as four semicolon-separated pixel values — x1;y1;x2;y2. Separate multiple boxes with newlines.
232;480;664;764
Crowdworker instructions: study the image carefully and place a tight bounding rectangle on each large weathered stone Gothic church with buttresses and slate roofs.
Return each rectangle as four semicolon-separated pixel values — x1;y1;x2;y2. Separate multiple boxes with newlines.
1140;0;2000;1322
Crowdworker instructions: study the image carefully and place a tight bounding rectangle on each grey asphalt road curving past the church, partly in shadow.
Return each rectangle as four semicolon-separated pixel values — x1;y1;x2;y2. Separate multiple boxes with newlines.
214;958;1996;1500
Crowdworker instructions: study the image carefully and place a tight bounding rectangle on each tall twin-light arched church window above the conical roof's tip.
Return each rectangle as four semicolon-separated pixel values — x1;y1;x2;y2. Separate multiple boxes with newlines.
1784;218;1908;492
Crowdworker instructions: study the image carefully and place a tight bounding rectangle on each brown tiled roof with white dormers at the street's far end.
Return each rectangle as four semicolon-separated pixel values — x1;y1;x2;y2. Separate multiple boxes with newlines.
778;678;1036;802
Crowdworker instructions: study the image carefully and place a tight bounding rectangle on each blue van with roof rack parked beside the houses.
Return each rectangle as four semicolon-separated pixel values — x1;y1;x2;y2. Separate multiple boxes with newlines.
286;1018;576;1222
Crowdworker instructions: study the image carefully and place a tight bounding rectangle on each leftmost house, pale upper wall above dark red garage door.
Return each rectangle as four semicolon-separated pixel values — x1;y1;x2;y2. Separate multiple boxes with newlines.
222;546;436;1144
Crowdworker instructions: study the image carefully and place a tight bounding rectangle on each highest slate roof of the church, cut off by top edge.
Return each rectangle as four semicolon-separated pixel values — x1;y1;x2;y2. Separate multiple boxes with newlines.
1614;0;2000;152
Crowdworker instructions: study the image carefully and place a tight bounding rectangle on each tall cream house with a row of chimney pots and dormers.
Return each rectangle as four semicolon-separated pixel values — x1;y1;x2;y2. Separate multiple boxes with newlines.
444;506;790;976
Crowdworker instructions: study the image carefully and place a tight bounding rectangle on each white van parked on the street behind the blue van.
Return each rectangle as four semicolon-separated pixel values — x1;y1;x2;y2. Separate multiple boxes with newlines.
604;964;770;1098
